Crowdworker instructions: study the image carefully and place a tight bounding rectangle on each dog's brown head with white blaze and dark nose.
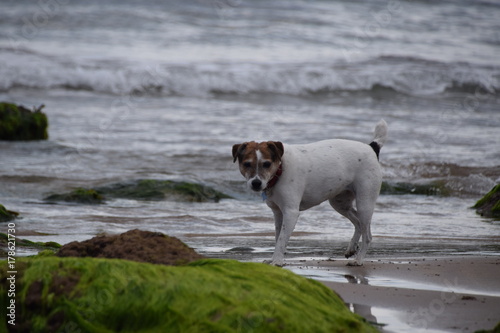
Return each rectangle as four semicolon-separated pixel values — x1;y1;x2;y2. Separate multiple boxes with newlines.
233;141;285;192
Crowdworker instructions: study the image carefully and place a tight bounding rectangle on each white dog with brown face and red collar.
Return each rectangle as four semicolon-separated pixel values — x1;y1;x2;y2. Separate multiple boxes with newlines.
232;119;388;266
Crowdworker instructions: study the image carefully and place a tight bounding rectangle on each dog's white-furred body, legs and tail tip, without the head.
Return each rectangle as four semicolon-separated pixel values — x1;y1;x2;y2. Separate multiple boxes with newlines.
266;120;387;266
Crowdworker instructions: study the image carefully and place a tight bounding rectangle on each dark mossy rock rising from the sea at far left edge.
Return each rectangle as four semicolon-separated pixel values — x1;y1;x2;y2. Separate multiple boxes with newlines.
0;102;49;140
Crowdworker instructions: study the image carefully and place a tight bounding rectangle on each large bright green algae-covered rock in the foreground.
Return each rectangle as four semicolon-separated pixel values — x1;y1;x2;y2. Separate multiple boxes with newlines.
0;257;377;333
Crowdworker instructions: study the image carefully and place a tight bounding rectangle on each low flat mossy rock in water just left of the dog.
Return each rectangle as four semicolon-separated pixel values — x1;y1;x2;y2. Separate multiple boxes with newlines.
97;179;231;202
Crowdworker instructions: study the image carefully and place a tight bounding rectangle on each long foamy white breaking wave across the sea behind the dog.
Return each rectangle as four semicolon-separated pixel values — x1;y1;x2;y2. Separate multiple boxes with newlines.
0;48;500;96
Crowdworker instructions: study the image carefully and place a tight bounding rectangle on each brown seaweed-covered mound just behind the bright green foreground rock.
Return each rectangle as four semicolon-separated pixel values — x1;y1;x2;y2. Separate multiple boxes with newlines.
57;229;203;265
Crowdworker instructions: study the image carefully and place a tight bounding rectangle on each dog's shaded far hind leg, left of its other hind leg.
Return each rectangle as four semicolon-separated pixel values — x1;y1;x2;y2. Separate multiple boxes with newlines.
330;190;361;258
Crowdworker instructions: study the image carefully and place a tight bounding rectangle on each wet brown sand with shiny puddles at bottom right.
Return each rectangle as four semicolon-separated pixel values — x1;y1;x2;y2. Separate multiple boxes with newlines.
287;256;500;332
